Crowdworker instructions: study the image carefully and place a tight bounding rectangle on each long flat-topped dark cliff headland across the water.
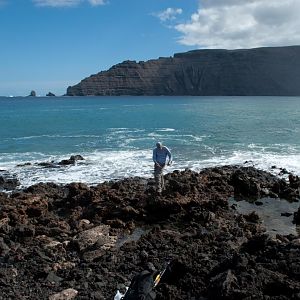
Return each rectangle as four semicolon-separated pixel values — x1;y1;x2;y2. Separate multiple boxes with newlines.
67;46;300;96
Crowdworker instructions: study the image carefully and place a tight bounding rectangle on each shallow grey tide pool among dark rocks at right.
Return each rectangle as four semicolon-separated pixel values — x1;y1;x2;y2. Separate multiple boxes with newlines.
229;198;300;236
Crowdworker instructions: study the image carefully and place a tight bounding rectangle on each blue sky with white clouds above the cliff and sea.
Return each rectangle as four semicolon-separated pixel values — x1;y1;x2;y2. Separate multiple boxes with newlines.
0;0;300;96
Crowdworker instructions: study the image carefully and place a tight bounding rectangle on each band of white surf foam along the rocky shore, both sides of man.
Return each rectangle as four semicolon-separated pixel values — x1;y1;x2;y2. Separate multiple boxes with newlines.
0;149;300;187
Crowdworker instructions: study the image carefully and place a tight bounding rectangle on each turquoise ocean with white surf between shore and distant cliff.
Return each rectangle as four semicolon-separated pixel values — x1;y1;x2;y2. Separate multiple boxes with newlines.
0;96;300;187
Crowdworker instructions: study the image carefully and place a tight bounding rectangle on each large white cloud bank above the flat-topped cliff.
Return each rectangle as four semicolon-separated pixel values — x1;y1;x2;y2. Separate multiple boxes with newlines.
175;0;300;49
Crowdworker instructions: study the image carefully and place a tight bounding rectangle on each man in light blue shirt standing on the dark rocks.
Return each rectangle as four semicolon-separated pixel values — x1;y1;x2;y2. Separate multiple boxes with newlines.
153;142;172;193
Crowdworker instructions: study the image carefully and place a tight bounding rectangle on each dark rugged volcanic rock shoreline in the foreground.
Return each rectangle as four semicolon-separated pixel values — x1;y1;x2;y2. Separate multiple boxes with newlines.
0;166;300;300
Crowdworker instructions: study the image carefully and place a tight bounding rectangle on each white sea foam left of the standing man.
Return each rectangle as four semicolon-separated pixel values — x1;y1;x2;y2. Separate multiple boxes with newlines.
0;151;152;187
